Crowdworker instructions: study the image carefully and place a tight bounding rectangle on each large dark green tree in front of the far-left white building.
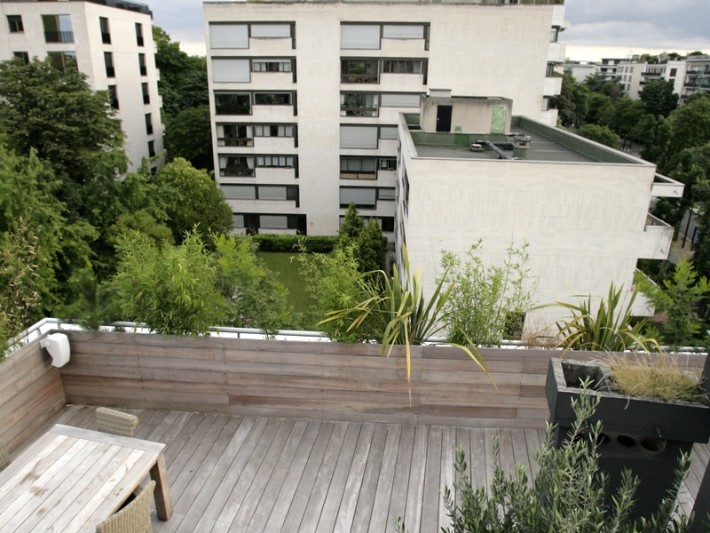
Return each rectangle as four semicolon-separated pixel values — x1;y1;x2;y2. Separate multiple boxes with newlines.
0;58;127;216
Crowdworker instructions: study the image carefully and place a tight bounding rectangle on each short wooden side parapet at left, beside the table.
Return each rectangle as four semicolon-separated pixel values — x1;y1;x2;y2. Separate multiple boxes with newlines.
0;340;66;451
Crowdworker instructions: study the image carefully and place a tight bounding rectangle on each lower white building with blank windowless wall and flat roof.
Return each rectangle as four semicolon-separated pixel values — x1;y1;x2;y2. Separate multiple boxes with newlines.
395;92;683;331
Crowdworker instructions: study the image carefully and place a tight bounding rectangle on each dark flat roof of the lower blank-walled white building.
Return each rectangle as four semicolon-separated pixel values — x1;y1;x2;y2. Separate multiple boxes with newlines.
406;115;652;165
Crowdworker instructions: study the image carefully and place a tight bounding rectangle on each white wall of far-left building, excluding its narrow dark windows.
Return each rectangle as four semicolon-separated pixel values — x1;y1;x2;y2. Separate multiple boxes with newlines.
0;2;163;170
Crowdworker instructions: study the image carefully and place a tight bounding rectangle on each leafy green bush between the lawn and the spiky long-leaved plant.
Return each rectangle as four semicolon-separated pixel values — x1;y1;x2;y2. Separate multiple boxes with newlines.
296;246;376;342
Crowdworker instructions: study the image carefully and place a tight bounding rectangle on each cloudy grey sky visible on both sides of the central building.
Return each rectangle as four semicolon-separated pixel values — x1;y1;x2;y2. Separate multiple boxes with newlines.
139;0;710;61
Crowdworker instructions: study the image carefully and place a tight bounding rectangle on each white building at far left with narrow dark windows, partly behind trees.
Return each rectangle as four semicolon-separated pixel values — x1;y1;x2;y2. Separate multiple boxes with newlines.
0;0;163;170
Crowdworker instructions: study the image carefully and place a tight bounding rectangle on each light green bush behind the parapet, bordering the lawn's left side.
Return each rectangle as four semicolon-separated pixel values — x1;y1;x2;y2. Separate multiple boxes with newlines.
215;235;293;332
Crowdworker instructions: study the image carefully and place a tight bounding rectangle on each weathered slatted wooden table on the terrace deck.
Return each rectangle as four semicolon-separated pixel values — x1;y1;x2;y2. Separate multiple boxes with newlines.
0;424;172;533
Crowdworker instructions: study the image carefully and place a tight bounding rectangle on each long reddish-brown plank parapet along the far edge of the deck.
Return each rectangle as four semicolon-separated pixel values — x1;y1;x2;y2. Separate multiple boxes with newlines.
61;332;702;428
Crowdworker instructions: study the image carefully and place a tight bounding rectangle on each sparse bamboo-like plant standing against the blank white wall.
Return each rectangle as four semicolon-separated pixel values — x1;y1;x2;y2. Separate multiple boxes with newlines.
441;241;534;345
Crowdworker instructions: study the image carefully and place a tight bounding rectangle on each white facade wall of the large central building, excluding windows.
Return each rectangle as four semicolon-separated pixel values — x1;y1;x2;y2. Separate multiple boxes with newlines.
204;2;561;235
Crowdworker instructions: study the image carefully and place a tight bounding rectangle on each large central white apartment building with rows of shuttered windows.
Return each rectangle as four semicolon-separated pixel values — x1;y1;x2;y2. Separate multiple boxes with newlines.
204;0;564;238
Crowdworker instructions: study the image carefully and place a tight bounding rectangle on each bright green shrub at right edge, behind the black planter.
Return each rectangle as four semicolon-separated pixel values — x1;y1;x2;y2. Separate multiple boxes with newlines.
637;259;710;347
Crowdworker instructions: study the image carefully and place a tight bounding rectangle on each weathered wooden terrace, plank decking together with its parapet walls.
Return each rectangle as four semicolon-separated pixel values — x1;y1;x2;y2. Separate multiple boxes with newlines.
0;324;710;533
